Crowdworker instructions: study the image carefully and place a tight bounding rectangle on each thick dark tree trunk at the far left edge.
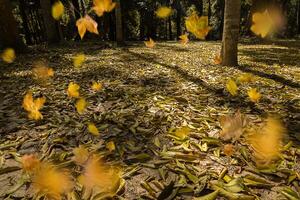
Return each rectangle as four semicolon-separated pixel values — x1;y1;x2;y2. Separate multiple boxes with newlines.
0;0;26;52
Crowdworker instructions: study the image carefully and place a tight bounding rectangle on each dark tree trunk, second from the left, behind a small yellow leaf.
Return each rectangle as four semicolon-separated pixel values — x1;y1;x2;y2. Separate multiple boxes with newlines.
40;0;60;43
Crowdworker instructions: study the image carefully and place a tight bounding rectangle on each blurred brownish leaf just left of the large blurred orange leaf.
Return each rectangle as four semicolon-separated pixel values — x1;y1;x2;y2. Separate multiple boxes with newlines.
220;111;246;140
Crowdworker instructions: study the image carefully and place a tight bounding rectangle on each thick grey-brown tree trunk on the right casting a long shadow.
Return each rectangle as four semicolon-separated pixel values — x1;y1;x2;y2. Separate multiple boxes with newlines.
221;0;241;66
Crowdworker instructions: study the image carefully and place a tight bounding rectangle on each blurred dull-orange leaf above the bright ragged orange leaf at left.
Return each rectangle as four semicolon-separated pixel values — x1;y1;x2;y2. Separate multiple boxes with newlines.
32;62;54;81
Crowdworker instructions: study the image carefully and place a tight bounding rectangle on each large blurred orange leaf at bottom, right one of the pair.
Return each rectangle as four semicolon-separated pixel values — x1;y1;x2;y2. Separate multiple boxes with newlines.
78;156;121;193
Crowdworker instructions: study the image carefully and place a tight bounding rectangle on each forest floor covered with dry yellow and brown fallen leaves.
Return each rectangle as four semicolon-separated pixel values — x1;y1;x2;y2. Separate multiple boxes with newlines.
0;40;300;199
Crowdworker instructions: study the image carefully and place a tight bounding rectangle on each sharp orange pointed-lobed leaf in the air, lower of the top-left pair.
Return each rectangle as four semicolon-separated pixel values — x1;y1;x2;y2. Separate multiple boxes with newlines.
76;15;99;39
